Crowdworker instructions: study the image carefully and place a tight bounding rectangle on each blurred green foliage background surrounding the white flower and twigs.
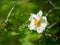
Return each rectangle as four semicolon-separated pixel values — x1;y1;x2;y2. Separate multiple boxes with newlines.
0;0;60;45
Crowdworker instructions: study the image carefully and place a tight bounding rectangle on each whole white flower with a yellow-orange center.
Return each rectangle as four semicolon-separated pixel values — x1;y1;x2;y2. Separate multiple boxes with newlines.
28;10;47;33
